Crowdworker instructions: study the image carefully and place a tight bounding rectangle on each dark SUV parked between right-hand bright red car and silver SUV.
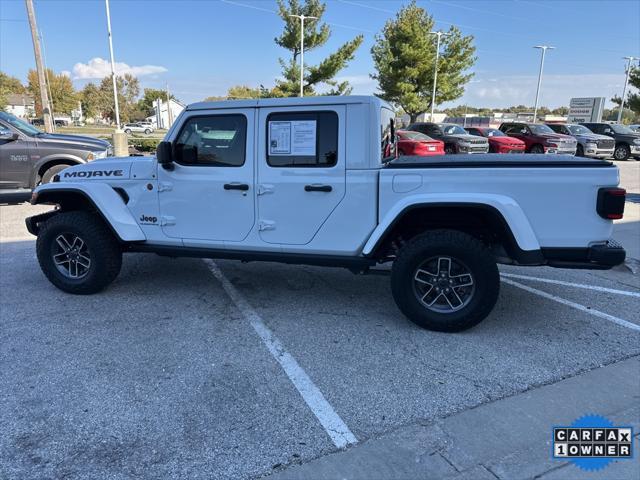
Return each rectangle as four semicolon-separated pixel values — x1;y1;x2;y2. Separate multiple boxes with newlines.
500;122;578;155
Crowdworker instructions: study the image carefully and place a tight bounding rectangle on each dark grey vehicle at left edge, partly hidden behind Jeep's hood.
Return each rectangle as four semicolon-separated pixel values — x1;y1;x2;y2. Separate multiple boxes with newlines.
0;111;113;202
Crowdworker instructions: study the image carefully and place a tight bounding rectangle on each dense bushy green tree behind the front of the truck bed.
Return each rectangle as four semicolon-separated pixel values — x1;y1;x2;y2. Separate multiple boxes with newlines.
371;0;476;122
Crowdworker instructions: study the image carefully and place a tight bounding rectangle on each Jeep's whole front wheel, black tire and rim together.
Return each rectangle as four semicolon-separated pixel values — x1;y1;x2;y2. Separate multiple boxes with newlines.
36;211;122;295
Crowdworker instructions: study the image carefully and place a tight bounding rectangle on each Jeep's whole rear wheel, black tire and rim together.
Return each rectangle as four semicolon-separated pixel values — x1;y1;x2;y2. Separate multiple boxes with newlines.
391;230;500;332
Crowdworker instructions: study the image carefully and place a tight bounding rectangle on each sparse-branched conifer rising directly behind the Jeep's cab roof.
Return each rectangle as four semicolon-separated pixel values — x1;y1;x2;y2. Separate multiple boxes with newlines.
269;0;363;97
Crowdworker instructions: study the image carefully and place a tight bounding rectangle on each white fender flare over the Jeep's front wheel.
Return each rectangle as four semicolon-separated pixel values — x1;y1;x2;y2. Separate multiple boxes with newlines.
31;182;147;242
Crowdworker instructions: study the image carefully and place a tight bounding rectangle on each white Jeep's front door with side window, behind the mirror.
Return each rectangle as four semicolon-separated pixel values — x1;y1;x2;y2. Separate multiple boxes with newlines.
158;109;255;242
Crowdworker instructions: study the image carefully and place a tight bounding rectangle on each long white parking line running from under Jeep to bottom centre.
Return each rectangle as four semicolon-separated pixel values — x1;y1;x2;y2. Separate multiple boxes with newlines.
204;259;358;448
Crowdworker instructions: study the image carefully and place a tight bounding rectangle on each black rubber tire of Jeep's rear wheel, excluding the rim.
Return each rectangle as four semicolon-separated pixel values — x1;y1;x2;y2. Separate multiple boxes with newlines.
391;230;500;332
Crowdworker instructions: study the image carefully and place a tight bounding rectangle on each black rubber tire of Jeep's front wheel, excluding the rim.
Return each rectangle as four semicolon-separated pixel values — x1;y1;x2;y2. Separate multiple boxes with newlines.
36;211;122;295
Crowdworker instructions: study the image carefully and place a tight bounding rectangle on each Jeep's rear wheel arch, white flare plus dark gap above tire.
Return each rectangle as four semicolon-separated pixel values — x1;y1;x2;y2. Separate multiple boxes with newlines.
363;200;544;264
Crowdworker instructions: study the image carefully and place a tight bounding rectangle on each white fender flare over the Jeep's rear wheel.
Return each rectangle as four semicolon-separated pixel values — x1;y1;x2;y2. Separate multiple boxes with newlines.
362;193;540;255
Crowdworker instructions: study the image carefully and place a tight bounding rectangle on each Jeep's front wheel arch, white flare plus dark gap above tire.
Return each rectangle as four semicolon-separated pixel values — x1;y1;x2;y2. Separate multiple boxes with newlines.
31;183;146;242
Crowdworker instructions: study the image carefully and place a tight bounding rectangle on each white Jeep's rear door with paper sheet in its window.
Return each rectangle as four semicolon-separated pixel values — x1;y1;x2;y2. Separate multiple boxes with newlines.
257;105;346;245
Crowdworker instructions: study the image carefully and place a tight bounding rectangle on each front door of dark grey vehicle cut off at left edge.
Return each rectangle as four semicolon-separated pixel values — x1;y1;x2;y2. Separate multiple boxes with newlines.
0;123;31;188
